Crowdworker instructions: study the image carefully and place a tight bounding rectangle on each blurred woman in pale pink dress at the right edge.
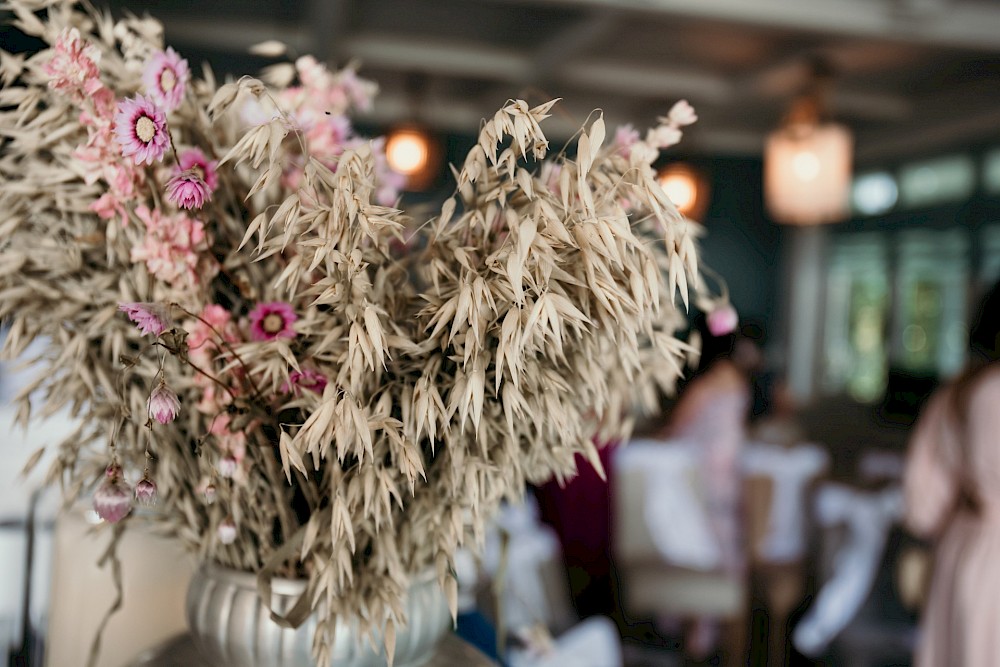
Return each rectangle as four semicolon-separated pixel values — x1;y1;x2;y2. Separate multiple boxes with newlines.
904;284;1000;667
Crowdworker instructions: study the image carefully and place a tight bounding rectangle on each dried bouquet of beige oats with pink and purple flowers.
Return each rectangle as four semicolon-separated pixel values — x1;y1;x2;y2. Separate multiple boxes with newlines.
0;0;716;662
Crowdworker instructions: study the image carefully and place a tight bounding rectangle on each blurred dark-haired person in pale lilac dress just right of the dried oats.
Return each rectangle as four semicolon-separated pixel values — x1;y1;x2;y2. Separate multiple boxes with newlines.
659;318;761;659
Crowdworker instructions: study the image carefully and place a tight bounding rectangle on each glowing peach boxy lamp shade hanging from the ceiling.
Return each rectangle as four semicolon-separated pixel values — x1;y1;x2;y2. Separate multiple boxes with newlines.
764;123;854;225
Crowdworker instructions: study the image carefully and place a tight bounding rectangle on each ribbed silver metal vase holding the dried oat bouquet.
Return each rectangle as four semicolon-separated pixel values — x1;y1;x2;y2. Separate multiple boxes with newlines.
187;564;451;667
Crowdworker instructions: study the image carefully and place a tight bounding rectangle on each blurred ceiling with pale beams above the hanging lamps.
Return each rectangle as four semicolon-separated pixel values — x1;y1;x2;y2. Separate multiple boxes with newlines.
101;0;1000;163
